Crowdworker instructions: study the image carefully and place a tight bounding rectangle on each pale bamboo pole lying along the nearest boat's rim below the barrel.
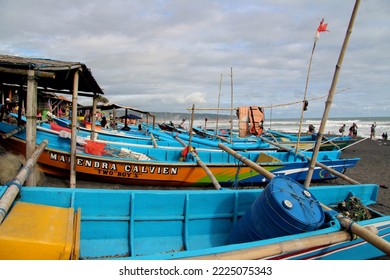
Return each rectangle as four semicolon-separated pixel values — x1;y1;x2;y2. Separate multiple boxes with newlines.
183;226;378;260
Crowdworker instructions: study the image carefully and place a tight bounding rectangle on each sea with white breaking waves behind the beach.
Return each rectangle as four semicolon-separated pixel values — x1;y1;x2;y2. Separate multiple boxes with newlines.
188;117;390;139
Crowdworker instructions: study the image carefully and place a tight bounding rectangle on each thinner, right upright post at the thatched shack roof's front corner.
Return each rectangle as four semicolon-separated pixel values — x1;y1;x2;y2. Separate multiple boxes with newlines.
69;69;80;188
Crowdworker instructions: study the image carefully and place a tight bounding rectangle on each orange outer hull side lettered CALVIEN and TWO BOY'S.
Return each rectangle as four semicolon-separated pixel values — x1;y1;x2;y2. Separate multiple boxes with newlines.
1;132;358;187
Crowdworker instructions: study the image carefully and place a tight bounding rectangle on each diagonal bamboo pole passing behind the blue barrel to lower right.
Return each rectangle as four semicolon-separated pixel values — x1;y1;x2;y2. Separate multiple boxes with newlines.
218;143;390;256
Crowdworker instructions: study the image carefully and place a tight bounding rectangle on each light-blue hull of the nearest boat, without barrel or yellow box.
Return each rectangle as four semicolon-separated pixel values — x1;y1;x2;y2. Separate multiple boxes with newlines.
0;184;390;260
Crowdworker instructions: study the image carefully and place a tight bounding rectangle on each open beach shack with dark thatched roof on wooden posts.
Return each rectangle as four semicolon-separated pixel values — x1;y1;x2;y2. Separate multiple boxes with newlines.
0;55;104;187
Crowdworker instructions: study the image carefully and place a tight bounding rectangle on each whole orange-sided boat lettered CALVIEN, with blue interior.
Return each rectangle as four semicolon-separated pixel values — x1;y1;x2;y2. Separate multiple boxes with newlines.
0;122;359;188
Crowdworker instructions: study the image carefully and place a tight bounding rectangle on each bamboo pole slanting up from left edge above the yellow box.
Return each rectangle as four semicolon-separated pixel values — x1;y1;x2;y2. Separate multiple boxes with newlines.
0;140;48;224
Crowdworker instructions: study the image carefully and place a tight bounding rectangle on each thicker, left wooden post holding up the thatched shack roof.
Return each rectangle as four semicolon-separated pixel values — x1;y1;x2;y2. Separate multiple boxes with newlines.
25;70;38;186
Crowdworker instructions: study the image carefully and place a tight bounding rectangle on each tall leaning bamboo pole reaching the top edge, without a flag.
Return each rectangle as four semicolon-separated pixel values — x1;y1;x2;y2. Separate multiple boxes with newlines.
304;0;360;187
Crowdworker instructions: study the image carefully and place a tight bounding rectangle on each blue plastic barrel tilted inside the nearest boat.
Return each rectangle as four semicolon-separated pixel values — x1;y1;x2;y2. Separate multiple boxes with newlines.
230;176;325;243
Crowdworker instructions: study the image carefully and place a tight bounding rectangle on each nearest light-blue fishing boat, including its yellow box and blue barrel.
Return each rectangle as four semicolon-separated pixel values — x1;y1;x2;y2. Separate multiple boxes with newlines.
0;177;390;260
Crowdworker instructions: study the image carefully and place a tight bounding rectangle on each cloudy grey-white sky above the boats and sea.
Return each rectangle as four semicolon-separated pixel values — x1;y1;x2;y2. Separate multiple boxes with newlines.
0;0;390;118
